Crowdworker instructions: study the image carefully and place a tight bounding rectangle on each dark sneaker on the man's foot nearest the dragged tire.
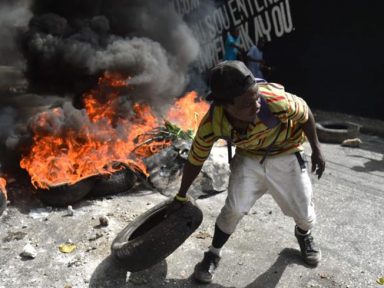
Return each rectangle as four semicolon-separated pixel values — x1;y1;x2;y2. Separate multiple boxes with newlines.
193;251;221;283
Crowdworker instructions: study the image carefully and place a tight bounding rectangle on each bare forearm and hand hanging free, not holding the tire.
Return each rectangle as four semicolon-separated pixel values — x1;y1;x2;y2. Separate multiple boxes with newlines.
301;107;325;179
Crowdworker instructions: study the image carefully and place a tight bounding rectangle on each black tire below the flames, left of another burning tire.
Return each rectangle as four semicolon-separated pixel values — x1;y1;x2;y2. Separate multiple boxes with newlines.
36;177;94;206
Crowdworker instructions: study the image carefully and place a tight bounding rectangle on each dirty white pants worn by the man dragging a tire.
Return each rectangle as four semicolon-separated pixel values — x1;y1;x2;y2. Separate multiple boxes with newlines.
216;153;316;234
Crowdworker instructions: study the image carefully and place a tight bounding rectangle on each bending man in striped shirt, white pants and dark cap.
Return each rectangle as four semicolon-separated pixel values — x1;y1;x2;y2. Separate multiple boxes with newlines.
174;61;325;283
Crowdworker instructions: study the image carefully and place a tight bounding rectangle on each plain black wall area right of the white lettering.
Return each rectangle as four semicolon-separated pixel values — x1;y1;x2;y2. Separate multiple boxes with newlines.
254;0;384;119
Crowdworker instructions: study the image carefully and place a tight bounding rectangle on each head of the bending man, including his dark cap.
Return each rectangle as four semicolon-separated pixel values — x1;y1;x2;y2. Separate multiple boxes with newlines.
207;61;260;122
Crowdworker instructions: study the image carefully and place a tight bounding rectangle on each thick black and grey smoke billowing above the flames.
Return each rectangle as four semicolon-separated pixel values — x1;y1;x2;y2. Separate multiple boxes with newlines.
0;0;199;172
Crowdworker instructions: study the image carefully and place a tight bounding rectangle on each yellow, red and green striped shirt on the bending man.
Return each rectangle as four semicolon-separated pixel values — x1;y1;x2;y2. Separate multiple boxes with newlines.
188;83;308;166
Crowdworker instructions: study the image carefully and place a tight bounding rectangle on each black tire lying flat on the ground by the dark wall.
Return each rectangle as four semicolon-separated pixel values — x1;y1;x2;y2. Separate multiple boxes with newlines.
316;121;360;143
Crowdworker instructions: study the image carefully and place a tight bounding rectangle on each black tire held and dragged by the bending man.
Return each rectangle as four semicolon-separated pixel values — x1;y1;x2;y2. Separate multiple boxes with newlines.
111;198;203;272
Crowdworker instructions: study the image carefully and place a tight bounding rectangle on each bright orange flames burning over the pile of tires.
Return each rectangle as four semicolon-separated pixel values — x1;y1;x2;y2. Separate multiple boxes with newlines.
20;73;208;189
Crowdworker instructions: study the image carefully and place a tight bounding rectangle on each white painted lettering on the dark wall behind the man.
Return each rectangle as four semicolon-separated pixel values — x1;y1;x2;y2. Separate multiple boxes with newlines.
174;0;294;72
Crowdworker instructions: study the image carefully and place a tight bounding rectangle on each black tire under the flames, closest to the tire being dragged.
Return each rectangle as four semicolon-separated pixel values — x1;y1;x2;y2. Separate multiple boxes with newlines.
88;167;137;197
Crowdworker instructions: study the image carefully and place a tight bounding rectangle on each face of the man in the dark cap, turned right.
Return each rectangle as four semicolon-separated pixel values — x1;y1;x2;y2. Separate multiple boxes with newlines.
224;85;261;123
